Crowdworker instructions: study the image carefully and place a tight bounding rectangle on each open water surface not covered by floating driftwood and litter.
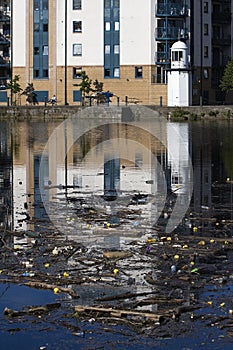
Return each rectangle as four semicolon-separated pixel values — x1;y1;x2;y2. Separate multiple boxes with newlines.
0;110;233;349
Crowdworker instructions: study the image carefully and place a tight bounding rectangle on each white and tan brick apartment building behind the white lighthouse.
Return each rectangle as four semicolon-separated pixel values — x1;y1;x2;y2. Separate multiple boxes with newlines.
0;0;233;105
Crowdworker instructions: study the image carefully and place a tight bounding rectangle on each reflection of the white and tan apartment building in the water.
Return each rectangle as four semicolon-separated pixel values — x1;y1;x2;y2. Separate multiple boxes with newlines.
0;109;231;245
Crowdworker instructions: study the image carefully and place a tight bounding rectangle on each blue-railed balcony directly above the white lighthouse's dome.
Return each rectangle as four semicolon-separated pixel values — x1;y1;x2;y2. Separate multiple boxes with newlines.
155;27;188;41
